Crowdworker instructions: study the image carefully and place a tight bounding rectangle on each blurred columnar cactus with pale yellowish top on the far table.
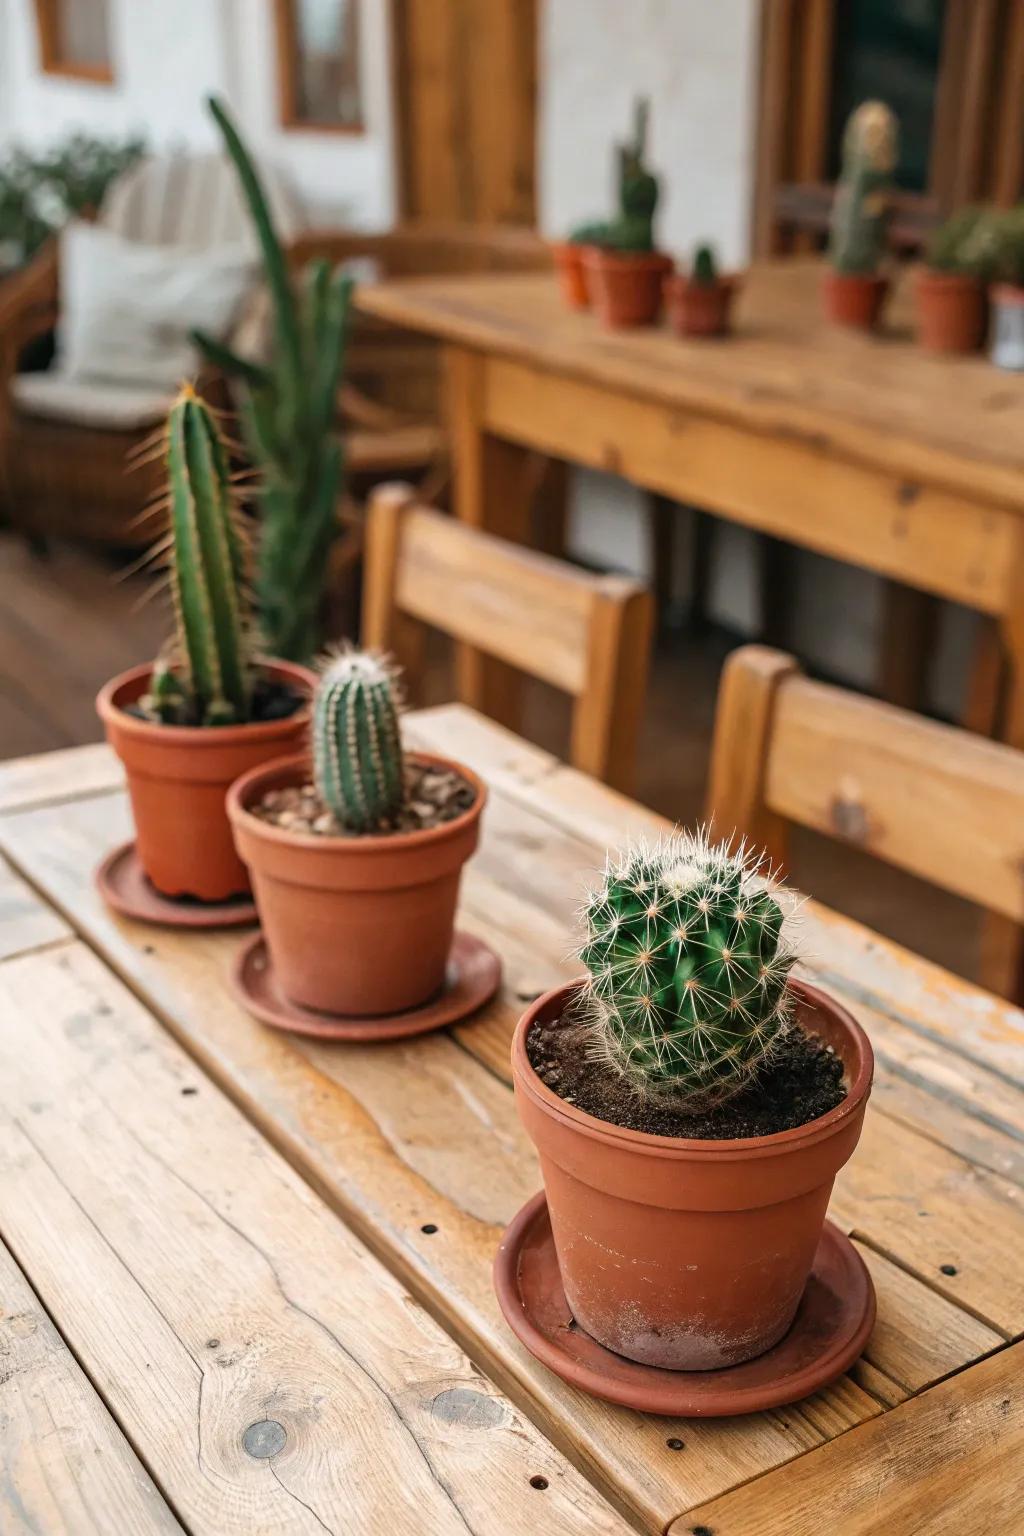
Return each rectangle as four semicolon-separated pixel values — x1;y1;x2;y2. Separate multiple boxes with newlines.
829;101;898;273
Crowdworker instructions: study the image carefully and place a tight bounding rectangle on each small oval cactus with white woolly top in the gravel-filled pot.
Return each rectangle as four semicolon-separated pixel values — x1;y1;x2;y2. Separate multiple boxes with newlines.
313;650;405;833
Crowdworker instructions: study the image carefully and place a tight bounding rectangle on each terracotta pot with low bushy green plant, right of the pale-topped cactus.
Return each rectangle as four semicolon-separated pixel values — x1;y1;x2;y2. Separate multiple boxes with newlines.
917;207;993;352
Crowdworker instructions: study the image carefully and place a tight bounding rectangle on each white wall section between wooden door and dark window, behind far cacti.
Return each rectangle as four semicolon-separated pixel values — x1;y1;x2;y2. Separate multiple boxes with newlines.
539;0;760;263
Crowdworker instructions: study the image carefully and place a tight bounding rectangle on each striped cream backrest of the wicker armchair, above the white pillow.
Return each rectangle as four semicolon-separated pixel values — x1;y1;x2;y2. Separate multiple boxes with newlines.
100;155;301;250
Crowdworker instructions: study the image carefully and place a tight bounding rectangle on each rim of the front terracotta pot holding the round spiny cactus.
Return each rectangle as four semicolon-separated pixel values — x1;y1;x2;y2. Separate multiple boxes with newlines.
511;977;875;1161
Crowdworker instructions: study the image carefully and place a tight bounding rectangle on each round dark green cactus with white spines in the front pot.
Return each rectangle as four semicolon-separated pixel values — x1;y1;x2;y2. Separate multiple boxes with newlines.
580;834;795;1107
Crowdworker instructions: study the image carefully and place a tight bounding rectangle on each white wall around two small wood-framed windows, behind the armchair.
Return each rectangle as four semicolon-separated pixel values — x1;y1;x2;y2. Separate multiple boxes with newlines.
0;0;395;229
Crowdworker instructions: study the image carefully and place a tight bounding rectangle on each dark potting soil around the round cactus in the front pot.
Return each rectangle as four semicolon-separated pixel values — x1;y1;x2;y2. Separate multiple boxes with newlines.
527;1020;846;1141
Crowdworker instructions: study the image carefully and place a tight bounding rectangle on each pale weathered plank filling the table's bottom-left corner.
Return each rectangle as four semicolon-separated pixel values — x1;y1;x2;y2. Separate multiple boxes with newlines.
0;1244;181;1536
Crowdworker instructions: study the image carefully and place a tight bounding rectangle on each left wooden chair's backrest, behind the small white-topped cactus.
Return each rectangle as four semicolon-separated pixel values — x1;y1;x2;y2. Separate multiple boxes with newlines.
362;485;652;788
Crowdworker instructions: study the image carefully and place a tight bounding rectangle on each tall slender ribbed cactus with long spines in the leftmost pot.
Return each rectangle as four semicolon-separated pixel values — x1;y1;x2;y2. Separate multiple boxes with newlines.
144;384;252;725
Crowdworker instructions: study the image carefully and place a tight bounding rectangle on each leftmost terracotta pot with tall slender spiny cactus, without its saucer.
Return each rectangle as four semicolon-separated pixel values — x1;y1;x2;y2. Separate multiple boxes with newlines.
97;386;313;902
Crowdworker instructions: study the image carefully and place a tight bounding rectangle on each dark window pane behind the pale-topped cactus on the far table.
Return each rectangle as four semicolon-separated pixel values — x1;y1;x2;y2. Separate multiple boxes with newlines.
829;0;946;192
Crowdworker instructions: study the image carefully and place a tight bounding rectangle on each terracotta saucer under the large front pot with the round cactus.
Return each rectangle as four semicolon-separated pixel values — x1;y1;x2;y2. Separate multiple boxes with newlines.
494;1190;875;1418
